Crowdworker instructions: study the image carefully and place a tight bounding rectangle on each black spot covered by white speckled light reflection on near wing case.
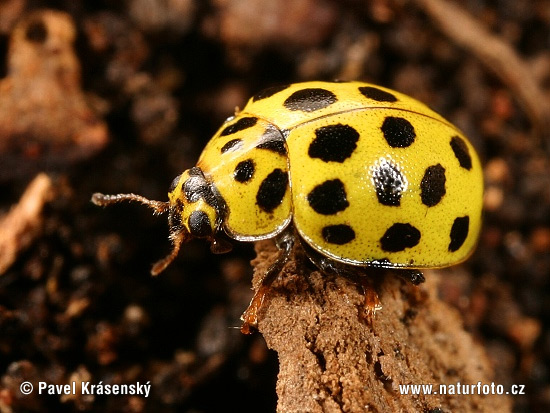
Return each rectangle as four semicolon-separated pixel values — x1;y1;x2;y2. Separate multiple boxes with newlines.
372;158;407;206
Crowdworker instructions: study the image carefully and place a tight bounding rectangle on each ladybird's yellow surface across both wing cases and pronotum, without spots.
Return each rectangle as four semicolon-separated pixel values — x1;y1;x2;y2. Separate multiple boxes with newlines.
193;82;483;268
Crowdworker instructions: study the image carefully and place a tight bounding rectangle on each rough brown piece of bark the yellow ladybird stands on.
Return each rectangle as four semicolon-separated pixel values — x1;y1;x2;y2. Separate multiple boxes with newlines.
253;241;510;412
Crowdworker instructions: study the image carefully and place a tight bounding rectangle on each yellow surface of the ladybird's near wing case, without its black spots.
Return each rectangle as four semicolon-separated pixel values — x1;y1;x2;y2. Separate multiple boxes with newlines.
287;109;483;268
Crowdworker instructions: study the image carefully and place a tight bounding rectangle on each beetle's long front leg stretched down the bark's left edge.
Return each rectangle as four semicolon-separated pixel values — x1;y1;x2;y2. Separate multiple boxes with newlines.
241;232;294;334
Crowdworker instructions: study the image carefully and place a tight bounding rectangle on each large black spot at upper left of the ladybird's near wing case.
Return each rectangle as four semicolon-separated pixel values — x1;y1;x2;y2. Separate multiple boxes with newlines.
308;123;359;163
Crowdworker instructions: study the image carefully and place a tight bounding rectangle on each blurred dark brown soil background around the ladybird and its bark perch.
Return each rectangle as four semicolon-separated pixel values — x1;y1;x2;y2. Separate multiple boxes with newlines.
0;0;550;413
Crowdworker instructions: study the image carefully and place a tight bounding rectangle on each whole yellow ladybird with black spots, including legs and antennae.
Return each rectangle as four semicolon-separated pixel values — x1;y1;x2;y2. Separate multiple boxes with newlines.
92;82;483;333
